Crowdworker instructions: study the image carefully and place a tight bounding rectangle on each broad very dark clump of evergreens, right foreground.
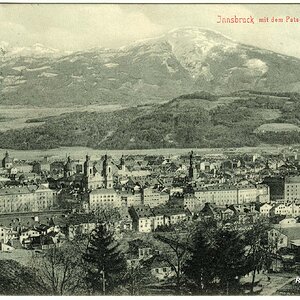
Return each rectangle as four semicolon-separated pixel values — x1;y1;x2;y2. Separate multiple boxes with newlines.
185;222;248;294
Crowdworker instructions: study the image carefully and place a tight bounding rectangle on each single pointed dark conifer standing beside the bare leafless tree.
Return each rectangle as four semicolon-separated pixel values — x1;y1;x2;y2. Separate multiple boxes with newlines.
83;223;126;295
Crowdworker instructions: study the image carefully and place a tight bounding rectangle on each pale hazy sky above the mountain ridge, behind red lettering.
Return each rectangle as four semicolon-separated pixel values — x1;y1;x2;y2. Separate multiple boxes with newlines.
0;4;300;57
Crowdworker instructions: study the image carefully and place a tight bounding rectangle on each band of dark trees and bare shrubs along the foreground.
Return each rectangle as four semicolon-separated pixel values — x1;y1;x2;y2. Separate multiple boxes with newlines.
0;221;274;295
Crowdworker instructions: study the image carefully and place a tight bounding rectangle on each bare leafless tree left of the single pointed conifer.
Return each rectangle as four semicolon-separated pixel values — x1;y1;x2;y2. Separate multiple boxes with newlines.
34;243;86;295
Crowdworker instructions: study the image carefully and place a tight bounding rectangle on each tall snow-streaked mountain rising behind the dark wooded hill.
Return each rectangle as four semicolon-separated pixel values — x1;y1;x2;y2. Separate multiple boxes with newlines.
0;27;300;106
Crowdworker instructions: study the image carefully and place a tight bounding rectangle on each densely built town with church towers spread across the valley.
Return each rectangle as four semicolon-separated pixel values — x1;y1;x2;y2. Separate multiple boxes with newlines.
0;147;300;295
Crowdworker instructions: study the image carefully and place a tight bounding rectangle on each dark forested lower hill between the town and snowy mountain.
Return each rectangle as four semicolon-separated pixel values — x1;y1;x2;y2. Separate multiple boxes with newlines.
0;91;300;149
